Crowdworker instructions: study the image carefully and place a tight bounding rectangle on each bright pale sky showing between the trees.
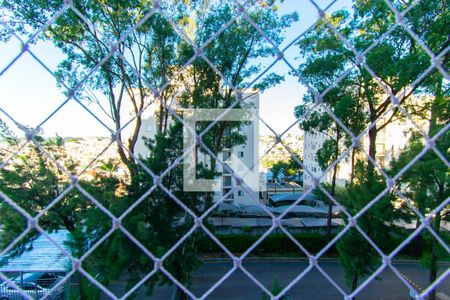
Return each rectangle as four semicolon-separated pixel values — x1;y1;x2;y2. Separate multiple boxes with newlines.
0;0;351;137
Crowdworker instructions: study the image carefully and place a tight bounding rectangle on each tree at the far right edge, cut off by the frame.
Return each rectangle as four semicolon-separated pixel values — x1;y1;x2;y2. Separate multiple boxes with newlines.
384;0;450;300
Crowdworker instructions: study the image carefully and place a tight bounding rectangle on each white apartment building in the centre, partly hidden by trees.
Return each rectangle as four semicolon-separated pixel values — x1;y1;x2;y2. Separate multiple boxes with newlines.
134;92;264;205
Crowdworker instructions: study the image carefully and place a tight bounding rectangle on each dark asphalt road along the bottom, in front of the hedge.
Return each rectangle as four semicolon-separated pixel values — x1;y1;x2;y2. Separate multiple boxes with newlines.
106;259;450;300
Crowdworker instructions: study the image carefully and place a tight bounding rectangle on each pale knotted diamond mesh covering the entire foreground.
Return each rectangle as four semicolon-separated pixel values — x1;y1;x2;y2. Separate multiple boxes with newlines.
0;0;450;299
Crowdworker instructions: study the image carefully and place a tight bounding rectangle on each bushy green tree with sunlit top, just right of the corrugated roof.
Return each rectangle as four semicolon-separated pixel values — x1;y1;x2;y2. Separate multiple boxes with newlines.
68;159;123;299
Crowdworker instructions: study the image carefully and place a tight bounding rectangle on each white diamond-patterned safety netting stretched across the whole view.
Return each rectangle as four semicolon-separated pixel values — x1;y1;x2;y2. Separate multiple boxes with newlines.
0;0;450;299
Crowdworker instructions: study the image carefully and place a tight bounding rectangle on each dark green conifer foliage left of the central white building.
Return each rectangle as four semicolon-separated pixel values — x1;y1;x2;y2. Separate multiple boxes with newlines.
135;122;206;285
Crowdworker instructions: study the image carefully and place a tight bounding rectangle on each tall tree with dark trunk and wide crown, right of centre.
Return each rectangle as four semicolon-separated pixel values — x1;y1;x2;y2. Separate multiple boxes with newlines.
298;1;448;179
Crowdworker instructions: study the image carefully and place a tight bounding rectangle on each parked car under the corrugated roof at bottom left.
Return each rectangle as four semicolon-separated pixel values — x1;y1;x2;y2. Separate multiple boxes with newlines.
0;272;64;300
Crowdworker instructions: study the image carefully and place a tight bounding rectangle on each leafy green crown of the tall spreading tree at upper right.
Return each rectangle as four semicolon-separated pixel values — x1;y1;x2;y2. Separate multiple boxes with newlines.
295;0;448;172
